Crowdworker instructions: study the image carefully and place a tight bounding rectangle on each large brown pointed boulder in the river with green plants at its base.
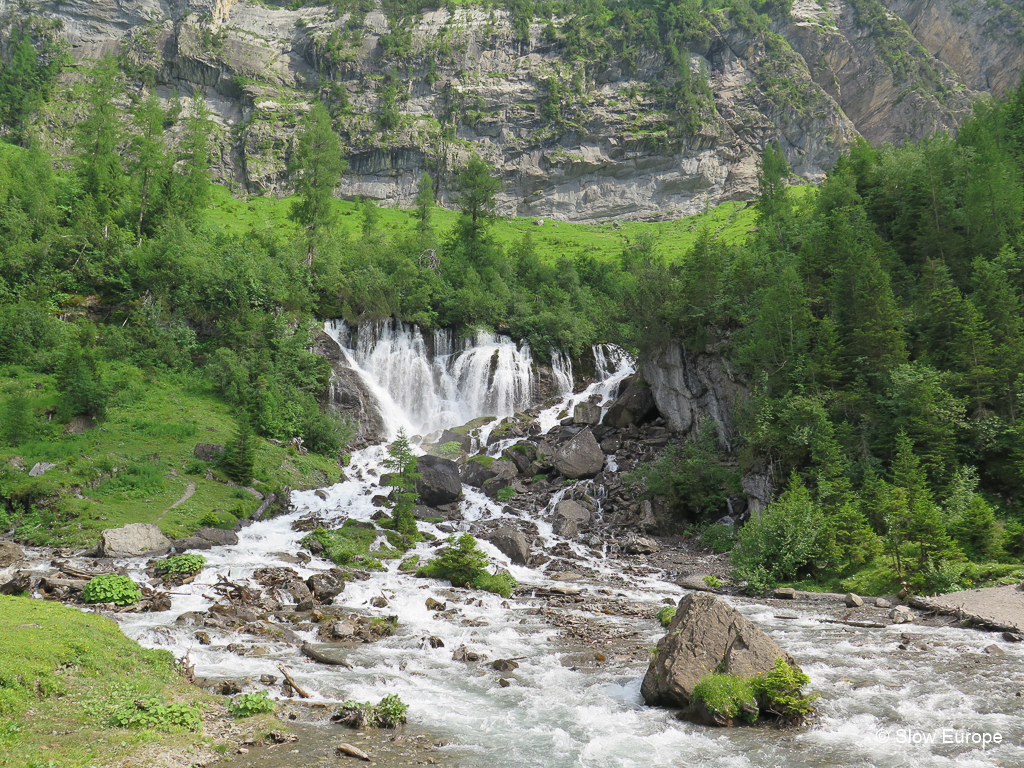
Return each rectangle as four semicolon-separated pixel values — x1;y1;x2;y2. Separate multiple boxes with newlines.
640;593;799;707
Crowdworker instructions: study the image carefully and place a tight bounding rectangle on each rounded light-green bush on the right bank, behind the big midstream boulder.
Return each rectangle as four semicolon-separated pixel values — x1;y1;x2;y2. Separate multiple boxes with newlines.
732;475;822;593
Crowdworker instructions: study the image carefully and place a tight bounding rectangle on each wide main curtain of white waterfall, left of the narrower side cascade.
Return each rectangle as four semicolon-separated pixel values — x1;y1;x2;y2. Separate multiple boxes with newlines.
325;319;534;437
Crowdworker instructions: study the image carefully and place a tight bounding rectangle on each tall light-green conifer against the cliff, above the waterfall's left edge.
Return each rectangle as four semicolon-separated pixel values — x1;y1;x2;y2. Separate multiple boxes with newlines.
288;103;348;267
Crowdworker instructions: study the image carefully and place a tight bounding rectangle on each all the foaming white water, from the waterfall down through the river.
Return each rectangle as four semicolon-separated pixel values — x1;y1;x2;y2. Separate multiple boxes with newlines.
103;326;1024;768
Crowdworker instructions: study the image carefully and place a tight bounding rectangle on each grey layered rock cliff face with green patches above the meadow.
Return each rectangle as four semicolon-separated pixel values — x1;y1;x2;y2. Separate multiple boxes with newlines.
9;0;1024;221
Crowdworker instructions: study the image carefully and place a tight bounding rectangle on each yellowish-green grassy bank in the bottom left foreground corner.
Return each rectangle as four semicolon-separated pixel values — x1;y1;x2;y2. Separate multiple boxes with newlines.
0;596;220;768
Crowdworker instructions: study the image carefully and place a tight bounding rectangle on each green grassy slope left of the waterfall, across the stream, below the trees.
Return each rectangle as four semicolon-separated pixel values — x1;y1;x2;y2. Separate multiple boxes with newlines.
0;366;341;546
